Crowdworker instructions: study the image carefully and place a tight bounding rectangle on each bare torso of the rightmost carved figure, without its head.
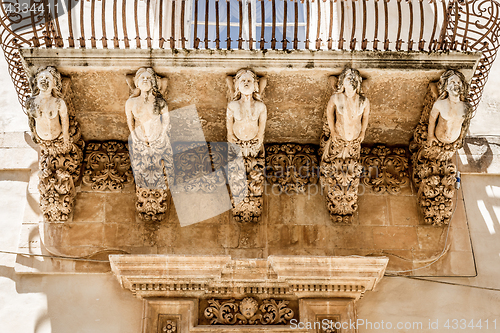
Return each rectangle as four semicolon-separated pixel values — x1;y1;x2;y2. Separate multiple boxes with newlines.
433;99;467;143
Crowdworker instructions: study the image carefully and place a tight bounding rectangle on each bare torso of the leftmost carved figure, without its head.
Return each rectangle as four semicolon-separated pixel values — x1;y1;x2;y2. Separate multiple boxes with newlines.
26;95;66;140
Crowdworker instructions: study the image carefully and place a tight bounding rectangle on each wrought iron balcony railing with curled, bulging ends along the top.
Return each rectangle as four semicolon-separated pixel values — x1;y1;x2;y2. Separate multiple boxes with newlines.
0;0;500;113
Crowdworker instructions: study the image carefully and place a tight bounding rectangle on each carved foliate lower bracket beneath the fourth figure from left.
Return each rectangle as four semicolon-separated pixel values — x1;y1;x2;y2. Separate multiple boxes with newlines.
319;127;363;223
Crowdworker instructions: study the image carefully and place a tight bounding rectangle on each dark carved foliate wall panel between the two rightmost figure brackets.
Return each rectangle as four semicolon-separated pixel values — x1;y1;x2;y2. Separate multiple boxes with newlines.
361;145;409;194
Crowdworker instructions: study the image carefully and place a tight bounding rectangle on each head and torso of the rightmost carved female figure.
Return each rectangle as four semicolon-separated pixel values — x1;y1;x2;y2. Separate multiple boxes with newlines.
427;70;470;146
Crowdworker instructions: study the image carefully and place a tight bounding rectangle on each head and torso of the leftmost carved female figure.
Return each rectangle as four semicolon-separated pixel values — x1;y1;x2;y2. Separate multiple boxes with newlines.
26;66;70;149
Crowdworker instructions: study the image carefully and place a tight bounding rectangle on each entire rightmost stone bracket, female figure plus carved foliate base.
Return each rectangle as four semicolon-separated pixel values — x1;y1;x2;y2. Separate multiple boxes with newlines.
410;70;472;226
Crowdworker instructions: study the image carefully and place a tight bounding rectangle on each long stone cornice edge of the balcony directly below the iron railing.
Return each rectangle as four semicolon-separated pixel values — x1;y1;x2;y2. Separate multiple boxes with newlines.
20;49;481;71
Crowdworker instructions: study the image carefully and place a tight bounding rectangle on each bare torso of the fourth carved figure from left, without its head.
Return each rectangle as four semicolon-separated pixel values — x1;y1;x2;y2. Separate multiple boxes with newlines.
331;93;366;141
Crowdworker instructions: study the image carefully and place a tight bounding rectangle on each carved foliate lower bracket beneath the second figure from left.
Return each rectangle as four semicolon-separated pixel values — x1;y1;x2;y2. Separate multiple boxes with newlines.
129;138;173;222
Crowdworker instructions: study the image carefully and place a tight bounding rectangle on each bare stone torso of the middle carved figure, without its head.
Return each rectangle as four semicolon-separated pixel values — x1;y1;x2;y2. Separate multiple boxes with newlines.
227;99;266;141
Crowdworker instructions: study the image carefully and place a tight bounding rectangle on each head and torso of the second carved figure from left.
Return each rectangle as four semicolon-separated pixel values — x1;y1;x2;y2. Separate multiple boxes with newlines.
125;68;170;144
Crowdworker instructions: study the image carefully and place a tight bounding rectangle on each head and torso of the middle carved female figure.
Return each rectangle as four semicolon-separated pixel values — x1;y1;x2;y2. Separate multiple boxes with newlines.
227;69;267;156
